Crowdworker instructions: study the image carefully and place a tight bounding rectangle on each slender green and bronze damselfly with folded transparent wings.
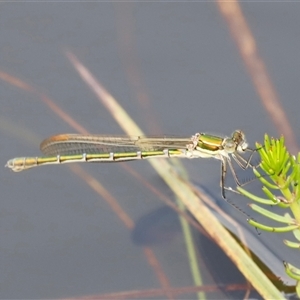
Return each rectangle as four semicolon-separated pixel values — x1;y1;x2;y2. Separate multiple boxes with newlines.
6;130;254;198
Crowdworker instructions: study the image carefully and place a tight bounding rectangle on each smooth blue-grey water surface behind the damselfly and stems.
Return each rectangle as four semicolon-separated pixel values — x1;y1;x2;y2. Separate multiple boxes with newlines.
0;1;300;299
